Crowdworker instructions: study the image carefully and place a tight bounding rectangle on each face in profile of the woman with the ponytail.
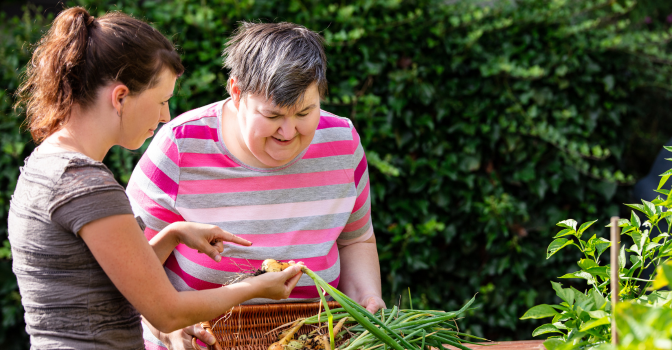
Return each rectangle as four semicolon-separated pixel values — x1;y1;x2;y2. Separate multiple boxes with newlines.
119;69;177;149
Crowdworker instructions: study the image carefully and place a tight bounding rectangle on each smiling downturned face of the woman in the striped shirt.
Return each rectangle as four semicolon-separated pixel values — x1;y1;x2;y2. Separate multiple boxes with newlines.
234;84;320;167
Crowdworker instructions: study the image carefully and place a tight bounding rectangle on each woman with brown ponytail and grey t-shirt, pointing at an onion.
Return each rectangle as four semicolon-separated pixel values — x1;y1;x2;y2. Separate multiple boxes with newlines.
8;7;300;349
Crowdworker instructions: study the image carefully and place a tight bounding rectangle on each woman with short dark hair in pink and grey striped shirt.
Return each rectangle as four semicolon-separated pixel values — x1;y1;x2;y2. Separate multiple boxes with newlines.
127;22;385;349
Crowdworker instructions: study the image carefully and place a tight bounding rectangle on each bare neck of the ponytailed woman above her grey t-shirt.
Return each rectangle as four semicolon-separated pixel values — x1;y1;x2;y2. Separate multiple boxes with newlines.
40;104;114;161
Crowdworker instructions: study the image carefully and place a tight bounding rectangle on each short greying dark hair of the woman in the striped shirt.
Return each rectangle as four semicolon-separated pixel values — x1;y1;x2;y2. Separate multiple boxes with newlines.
222;22;327;107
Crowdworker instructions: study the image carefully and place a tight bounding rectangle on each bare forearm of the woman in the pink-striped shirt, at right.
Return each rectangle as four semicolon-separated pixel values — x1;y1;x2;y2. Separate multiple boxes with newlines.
339;235;385;313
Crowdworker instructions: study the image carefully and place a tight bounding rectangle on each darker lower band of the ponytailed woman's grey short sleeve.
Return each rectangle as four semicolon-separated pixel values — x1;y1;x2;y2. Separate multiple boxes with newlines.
51;190;133;235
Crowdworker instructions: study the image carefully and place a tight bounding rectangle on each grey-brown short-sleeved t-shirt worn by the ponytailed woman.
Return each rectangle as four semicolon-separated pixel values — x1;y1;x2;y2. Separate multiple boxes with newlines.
8;152;144;349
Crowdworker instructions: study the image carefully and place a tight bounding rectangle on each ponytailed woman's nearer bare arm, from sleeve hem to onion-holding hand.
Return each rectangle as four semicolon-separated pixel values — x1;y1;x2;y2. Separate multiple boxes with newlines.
79;214;301;332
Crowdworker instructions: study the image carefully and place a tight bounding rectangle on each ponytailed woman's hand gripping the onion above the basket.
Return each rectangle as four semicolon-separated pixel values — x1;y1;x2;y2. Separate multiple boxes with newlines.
245;261;303;300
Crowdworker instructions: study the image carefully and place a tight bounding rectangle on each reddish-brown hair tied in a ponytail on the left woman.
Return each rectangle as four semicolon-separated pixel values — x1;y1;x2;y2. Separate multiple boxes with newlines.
15;7;184;143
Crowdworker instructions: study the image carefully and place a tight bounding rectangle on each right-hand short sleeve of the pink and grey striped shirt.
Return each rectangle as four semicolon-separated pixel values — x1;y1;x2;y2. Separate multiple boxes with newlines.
337;124;373;246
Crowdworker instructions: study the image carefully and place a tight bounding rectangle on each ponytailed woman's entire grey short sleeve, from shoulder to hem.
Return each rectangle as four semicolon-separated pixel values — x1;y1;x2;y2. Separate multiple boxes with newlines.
48;163;133;235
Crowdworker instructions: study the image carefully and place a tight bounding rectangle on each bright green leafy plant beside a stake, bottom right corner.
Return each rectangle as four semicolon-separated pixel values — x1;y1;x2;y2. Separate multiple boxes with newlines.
522;146;672;350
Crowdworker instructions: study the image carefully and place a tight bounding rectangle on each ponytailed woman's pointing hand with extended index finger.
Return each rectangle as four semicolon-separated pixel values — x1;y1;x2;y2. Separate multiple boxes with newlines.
168;221;252;262
